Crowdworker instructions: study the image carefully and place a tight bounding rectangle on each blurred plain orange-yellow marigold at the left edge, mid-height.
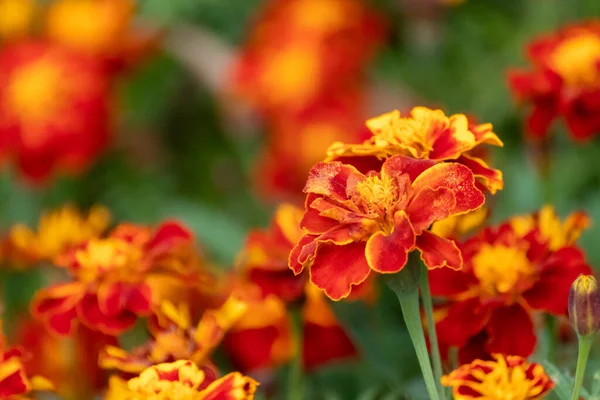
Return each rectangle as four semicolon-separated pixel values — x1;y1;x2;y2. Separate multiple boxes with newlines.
7;205;110;263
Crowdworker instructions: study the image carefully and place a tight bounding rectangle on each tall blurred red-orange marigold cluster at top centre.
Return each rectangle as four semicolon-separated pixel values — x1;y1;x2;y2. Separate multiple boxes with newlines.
232;0;384;198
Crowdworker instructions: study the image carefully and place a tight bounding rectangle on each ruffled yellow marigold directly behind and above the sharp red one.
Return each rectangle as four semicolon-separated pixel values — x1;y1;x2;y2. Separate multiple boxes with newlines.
327;107;504;194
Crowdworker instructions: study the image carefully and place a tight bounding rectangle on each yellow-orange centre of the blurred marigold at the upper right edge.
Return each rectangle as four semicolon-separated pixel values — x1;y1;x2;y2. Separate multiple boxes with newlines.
550;33;600;87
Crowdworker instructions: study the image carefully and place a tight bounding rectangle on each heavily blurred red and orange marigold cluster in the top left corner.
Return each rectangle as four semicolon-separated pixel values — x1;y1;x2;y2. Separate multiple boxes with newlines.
0;0;154;182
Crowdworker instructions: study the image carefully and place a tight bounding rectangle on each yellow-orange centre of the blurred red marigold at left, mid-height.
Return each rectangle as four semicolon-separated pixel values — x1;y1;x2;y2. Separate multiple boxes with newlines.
75;239;142;282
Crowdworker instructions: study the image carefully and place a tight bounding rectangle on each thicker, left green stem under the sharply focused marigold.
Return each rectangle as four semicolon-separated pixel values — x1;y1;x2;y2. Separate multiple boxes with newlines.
398;290;440;400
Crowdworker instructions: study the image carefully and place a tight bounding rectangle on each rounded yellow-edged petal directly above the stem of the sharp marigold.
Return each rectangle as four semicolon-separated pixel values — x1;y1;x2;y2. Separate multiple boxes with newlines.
365;211;415;274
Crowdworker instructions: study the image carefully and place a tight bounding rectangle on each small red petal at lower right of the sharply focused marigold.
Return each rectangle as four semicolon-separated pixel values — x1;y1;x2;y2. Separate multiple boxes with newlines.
417;231;463;270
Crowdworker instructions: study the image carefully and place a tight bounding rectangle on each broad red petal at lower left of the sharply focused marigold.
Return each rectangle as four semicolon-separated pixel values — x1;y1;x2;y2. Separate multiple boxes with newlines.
310;242;371;300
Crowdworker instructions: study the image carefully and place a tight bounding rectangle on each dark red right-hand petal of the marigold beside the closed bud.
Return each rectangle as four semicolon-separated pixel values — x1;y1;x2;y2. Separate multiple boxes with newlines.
523;247;592;315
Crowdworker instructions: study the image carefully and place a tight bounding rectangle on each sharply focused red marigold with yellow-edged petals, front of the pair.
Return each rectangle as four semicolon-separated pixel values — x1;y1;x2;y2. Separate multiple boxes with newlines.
290;156;485;300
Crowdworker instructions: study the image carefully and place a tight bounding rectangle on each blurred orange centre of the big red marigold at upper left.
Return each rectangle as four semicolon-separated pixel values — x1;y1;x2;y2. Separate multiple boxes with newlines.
6;58;71;146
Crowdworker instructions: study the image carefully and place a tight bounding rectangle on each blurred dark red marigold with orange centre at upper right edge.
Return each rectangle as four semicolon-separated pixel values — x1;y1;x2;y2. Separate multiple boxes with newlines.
509;20;600;140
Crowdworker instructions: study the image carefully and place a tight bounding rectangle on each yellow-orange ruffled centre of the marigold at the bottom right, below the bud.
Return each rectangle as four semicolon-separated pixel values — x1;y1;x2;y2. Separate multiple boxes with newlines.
468;358;543;400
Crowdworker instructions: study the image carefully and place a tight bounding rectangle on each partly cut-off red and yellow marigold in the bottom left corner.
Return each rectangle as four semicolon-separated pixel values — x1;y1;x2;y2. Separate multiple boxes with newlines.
0;321;52;400
